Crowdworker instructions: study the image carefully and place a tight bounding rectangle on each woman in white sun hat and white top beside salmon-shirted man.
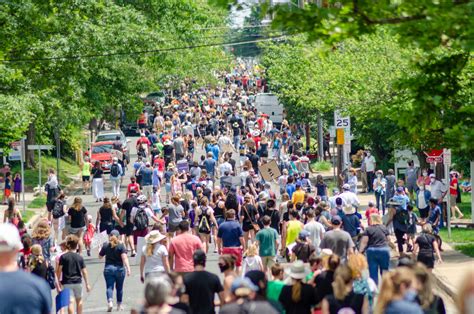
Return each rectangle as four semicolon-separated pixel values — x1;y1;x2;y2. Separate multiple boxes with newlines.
140;230;170;282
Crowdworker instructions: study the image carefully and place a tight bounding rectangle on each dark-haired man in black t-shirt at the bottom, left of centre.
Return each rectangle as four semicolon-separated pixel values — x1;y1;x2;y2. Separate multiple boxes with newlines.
184;250;225;314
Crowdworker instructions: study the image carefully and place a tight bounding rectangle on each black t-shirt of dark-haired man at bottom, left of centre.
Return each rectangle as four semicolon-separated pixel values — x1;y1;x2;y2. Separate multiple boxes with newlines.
184;270;224;314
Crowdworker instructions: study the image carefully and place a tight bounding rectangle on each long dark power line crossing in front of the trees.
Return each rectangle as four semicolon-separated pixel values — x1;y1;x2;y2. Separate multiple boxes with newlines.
0;35;286;63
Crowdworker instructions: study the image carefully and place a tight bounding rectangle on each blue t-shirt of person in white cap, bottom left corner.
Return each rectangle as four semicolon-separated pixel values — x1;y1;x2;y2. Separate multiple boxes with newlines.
0;270;52;314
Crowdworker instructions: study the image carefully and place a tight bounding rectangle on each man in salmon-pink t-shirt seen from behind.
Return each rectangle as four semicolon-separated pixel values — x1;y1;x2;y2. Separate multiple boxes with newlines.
168;220;202;274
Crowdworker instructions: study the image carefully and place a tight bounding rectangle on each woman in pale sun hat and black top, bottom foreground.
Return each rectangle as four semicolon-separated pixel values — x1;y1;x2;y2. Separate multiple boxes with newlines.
278;261;316;314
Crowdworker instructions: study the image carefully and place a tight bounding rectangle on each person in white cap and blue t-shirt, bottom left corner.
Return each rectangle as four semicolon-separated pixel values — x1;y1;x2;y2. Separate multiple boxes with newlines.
0;223;52;314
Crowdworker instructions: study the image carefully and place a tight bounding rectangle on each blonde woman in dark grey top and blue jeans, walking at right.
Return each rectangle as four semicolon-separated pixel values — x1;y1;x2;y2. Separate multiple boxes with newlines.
359;214;390;284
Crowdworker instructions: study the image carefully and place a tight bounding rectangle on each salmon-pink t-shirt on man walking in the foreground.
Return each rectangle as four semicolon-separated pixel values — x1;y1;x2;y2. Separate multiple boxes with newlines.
169;233;202;273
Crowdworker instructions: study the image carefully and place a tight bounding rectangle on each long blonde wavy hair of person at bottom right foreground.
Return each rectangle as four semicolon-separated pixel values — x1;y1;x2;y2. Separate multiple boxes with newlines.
374;267;414;314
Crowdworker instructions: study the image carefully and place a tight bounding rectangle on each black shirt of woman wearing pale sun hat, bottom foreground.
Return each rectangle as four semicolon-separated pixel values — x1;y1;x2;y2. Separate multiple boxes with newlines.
278;283;316;314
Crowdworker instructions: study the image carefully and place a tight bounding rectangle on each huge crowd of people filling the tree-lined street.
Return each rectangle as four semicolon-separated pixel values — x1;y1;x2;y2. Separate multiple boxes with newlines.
0;62;473;314
